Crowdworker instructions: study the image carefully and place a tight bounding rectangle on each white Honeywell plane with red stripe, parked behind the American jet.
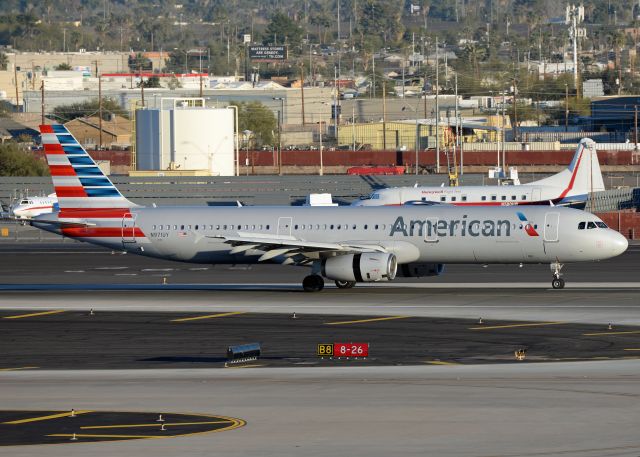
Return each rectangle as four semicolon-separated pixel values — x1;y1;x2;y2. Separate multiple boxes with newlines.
352;138;605;208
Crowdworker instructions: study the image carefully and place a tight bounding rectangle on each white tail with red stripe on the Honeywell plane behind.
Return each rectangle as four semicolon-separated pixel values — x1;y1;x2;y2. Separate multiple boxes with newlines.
529;138;605;198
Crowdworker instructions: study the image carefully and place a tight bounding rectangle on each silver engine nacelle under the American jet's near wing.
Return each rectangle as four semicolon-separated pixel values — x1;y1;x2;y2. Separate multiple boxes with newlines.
322;252;398;282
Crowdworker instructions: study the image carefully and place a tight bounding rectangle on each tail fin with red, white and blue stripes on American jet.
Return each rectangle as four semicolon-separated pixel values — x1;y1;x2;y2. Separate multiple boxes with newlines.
40;124;138;210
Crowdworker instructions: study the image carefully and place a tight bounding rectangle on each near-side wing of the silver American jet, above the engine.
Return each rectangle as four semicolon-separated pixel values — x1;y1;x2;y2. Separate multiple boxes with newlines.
211;232;387;265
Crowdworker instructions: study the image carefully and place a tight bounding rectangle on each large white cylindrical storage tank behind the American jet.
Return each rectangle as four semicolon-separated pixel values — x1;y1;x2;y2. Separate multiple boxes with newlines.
136;98;235;176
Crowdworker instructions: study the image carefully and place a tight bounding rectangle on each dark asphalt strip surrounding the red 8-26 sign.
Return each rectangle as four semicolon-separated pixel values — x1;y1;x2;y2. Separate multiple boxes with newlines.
0;309;640;371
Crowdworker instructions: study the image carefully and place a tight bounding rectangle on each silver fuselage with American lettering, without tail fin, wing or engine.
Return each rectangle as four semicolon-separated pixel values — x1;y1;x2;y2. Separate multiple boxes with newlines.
32;205;627;264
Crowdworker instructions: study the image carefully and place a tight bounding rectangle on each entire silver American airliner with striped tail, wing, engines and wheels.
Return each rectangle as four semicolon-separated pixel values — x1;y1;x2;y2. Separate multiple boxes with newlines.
31;125;627;291
